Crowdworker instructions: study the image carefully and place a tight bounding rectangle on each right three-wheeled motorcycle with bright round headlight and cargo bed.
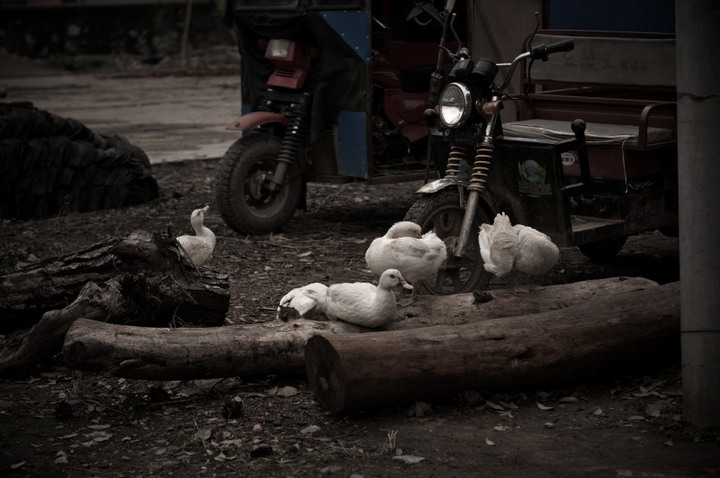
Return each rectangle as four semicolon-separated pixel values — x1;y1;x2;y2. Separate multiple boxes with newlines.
405;0;678;294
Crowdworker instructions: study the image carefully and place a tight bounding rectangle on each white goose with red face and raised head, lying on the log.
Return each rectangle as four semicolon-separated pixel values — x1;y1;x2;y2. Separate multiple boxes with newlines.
304;269;412;328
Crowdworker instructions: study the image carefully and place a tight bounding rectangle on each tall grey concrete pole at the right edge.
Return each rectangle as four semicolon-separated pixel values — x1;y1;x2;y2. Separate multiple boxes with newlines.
675;0;720;427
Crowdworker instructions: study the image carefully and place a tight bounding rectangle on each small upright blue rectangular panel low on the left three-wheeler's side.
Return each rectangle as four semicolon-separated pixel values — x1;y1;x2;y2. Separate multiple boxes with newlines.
337;111;368;179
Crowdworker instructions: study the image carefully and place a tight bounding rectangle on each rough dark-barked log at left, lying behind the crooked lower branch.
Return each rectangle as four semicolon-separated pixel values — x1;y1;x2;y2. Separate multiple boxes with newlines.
0;229;230;332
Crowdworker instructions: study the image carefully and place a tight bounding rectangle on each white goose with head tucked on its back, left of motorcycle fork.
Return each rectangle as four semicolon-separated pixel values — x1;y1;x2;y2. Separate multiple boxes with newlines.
365;221;447;299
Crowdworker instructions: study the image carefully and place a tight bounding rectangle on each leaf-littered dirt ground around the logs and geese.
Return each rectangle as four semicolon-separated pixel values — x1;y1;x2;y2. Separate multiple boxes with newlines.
0;52;720;478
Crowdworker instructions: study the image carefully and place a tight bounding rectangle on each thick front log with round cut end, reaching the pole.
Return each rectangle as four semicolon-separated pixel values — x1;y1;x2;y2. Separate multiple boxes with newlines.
305;282;680;412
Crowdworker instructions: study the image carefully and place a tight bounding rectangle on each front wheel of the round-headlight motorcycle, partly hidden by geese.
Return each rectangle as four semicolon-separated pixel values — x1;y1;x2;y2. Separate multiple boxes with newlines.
405;188;492;295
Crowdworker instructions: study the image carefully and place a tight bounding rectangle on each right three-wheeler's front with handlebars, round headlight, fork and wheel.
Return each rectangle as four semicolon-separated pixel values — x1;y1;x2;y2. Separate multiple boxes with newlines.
405;1;576;294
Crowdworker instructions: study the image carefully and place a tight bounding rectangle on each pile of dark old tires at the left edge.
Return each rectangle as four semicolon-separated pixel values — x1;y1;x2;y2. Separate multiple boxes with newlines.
0;102;159;219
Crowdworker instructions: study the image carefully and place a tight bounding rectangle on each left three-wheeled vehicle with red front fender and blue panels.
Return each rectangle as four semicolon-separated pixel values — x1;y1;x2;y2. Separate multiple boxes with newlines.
216;0;458;234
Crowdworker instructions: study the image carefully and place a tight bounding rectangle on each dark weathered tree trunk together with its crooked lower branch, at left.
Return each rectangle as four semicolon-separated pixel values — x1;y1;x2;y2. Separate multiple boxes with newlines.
0;231;230;375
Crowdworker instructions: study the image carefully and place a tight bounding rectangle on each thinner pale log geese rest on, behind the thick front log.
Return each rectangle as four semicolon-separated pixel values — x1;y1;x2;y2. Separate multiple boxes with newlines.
63;278;658;380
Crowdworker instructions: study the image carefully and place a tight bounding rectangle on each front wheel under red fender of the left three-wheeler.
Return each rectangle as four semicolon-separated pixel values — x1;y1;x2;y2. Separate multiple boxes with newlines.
216;134;302;234
